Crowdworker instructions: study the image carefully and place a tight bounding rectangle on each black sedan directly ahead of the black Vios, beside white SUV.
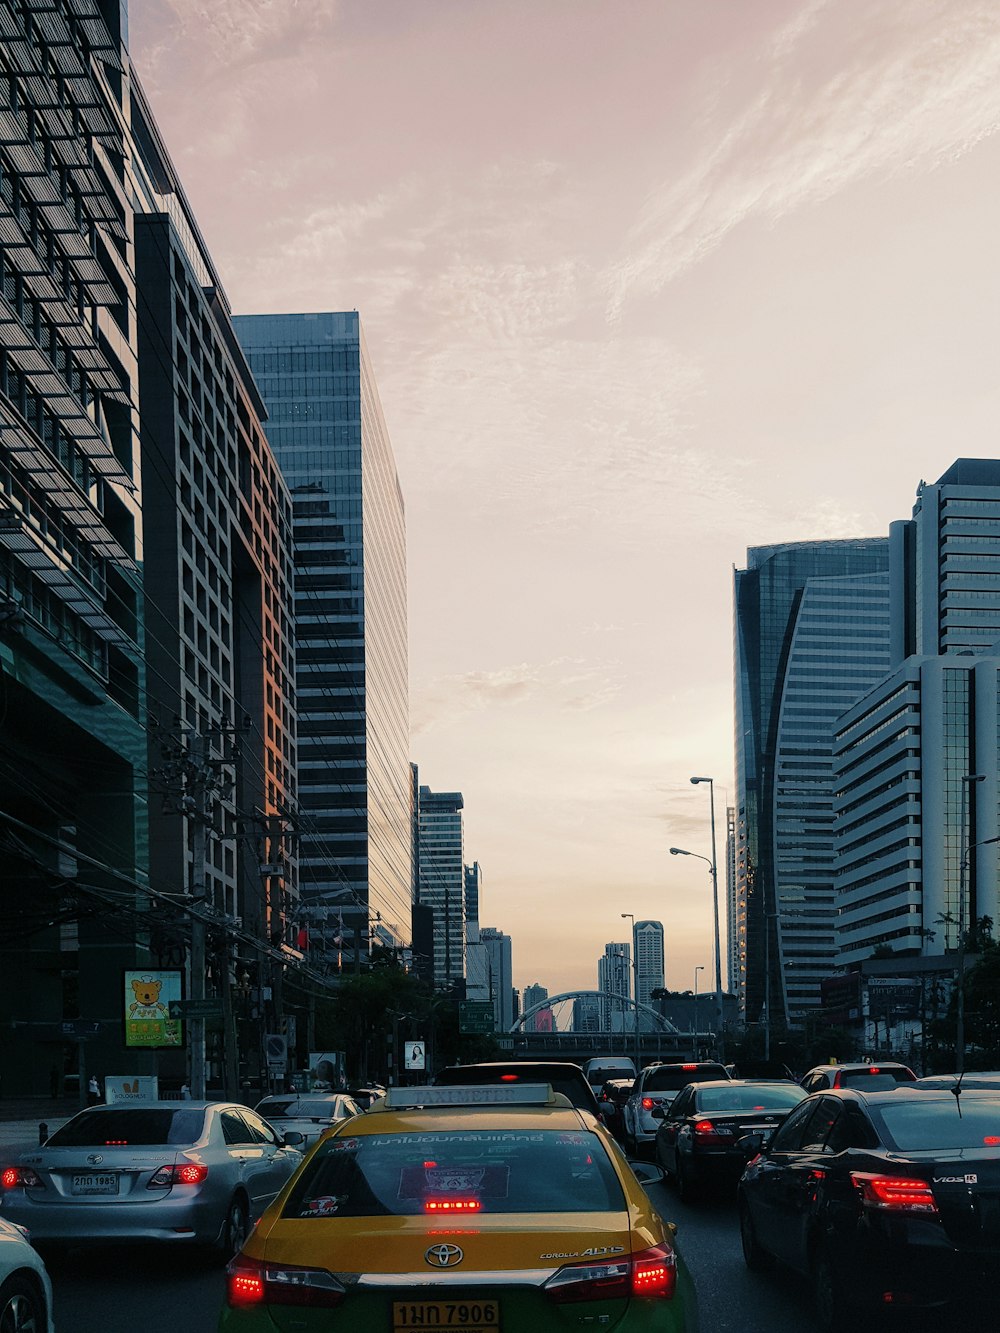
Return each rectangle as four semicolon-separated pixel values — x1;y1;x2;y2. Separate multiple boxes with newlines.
652;1078;805;1202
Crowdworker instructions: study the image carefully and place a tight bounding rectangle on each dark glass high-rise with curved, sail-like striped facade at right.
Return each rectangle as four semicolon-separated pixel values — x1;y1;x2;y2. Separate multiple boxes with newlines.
735;539;889;1028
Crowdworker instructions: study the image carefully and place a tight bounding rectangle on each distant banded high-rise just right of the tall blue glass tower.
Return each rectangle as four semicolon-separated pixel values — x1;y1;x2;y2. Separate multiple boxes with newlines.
417;786;469;990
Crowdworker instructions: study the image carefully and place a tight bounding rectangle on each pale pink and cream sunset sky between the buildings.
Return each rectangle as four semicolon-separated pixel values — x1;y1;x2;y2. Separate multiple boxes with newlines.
129;0;1000;993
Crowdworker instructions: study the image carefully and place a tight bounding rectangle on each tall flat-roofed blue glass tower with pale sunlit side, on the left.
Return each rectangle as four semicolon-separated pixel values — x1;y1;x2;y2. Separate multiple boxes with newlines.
233;312;410;952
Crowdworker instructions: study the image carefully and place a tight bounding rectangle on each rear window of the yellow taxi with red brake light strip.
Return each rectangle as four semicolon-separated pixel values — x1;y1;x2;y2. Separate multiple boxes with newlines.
283;1129;625;1217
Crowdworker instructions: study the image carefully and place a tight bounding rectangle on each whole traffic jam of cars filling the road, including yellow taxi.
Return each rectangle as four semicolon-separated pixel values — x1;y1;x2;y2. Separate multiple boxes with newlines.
0;1061;1000;1333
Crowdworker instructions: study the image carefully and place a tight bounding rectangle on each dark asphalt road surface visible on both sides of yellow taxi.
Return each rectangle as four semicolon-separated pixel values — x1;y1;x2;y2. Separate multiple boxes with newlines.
49;1185;812;1333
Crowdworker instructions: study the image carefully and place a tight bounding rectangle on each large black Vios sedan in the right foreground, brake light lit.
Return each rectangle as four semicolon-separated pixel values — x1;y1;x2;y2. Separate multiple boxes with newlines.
737;1085;1000;1333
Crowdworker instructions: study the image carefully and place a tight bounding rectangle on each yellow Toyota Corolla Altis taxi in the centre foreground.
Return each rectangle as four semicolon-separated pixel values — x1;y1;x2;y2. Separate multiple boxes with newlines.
219;1084;697;1333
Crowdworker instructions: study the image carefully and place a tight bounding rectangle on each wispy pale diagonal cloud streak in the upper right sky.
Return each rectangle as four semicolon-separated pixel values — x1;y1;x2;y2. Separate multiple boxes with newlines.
608;0;1000;320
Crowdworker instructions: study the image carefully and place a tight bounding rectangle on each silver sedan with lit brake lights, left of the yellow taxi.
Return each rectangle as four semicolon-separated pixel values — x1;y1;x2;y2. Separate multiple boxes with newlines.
0;1101;303;1257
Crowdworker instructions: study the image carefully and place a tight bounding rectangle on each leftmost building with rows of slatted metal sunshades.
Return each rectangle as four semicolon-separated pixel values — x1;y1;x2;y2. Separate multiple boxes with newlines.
0;0;146;1096
